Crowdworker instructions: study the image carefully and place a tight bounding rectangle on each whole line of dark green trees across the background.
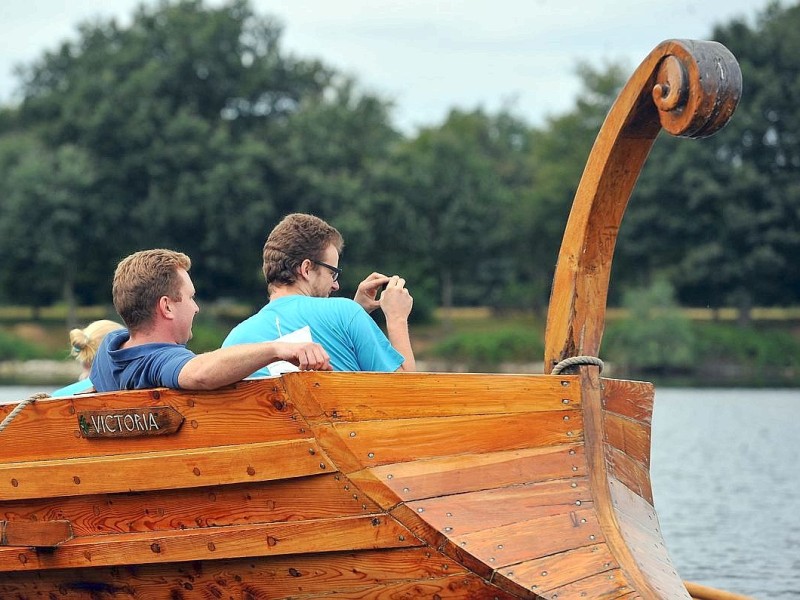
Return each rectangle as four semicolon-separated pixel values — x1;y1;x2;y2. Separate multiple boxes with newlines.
0;0;800;324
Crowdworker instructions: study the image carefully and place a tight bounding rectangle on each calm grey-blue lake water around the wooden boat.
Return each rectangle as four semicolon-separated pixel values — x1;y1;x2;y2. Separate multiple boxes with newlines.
0;386;800;600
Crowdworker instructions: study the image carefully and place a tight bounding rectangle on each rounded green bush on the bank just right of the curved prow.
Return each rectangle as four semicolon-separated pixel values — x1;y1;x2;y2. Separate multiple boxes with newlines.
603;280;694;373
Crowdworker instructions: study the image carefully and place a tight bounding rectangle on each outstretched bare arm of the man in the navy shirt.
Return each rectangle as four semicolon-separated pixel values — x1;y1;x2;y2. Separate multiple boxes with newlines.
178;342;332;390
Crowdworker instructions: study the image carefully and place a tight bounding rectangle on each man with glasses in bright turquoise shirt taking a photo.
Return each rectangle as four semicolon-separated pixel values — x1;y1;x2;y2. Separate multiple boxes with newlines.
222;213;416;376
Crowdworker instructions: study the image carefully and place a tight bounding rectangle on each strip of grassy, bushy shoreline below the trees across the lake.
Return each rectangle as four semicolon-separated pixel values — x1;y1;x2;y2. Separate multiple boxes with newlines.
0;299;800;387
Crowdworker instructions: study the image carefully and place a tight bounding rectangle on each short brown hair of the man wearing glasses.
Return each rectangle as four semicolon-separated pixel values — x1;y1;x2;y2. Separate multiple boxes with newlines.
263;213;344;292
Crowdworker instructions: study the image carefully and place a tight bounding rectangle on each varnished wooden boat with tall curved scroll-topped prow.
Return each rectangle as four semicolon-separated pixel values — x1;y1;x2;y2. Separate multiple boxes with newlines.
0;41;741;600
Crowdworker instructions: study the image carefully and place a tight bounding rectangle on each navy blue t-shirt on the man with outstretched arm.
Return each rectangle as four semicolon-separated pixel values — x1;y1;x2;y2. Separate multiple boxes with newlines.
90;329;196;392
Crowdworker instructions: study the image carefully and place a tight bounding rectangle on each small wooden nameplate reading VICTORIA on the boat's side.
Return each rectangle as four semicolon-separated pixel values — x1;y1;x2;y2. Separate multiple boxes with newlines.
78;406;184;438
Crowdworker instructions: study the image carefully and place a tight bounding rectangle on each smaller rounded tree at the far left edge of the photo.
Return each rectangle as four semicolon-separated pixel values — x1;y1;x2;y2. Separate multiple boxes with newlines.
0;135;100;326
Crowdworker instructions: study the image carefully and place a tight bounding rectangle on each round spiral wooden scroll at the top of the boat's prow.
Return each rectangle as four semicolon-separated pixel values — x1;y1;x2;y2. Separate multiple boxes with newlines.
652;40;742;138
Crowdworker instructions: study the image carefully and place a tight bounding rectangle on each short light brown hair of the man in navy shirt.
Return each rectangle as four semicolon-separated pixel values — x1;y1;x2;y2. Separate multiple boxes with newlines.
112;248;192;332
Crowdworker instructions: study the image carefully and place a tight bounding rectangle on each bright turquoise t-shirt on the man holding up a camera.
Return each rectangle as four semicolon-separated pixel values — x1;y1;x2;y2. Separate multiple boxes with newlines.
222;295;405;377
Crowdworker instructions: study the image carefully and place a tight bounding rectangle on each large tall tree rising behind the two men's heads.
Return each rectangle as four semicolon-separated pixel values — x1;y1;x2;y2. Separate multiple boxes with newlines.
0;0;391;304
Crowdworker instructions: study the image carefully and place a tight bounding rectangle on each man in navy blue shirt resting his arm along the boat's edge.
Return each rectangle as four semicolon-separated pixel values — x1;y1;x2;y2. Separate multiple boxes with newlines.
90;249;331;392
